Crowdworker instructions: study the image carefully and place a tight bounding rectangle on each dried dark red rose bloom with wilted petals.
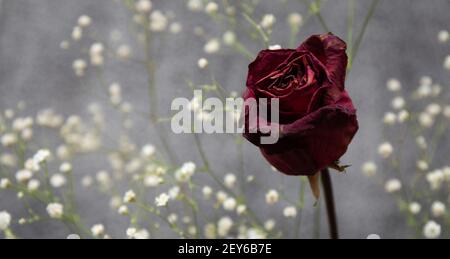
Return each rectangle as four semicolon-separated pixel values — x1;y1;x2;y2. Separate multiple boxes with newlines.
244;34;358;176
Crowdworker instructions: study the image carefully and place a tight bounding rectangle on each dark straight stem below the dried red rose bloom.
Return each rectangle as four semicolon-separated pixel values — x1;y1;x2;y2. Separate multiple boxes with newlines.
321;168;339;239
